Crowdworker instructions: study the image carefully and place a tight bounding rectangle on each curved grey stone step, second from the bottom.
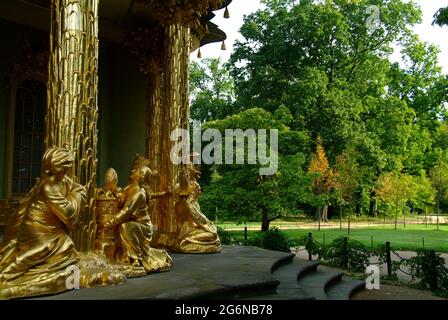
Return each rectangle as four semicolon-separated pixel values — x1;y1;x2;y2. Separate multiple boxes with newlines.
299;270;344;300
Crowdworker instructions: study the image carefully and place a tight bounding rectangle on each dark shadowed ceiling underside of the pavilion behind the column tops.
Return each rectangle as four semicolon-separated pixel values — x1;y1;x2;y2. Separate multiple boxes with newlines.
0;0;232;45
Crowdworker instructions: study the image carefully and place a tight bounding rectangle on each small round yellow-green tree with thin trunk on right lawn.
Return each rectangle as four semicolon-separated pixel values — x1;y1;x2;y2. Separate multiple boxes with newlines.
375;172;413;230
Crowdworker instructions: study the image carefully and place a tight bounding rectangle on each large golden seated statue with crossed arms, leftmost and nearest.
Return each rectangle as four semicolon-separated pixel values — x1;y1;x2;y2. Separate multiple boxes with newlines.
0;147;126;299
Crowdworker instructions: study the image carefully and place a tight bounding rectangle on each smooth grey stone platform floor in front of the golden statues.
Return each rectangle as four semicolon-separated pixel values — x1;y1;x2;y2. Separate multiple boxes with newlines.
34;246;291;300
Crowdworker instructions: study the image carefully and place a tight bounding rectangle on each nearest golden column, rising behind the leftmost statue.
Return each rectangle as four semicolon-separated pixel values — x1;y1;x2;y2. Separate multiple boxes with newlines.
45;0;99;252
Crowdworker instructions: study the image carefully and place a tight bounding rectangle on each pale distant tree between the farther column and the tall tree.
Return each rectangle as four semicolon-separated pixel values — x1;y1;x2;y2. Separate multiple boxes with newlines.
190;58;236;121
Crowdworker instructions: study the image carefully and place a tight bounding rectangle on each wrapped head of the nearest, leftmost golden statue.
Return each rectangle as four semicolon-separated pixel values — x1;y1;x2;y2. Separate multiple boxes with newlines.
42;147;75;175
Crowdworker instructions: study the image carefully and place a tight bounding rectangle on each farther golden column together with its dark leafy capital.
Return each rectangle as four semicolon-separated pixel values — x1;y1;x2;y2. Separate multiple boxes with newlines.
127;0;221;251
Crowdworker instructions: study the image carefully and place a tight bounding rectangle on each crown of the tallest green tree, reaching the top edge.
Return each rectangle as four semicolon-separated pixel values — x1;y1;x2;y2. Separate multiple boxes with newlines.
231;0;421;132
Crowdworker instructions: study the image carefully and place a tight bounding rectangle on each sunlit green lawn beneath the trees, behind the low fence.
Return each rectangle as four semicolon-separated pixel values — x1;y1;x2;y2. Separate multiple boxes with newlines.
226;225;448;252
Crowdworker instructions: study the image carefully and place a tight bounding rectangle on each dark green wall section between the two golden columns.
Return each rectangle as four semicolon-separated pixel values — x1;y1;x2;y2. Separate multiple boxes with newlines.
98;43;146;186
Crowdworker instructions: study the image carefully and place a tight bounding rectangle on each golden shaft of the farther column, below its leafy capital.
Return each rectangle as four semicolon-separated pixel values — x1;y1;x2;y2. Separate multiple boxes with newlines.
147;23;191;249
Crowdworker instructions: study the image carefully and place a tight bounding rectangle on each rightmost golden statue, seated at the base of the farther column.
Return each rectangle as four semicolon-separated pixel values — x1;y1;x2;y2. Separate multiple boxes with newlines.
175;164;221;253
